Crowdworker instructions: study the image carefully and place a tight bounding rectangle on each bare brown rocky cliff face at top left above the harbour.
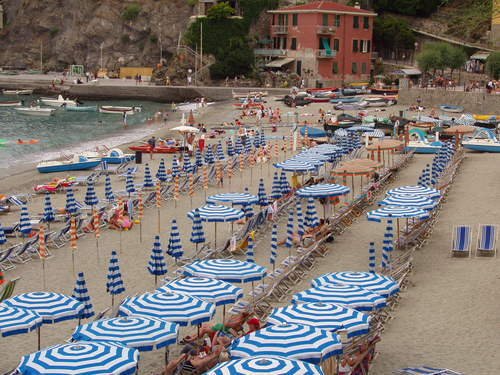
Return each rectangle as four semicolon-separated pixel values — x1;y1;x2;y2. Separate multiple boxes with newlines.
0;0;193;70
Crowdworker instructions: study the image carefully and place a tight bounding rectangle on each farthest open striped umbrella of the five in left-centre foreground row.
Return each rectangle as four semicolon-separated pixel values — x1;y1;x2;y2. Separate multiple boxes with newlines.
182;259;267;283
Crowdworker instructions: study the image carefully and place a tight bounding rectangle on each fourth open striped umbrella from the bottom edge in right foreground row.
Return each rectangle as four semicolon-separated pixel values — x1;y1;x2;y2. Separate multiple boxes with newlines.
293;284;387;311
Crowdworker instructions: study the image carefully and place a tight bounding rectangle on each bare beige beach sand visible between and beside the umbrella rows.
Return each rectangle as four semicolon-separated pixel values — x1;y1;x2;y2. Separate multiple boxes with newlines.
0;97;500;375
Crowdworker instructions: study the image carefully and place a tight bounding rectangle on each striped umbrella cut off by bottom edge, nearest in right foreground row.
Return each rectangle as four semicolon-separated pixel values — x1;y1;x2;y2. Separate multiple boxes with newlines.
205;356;324;375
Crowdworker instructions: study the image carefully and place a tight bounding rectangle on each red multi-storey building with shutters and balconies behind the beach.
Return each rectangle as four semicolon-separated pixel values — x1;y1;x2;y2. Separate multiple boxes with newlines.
266;1;376;86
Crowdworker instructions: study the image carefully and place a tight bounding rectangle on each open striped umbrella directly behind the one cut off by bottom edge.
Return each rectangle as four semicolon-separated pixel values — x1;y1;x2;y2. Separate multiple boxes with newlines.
230;324;342;365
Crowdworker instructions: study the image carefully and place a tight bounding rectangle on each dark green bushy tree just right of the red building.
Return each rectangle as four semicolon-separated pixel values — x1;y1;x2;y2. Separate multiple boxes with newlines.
373;16;415;49
